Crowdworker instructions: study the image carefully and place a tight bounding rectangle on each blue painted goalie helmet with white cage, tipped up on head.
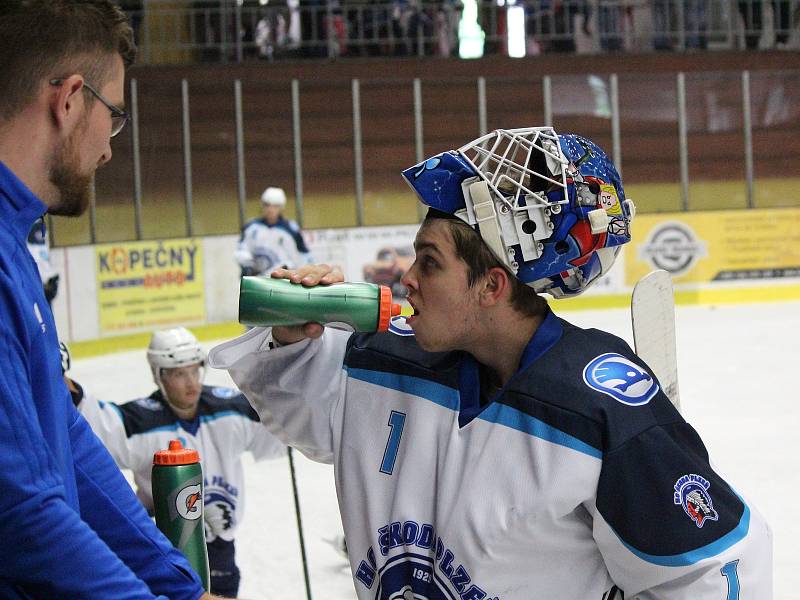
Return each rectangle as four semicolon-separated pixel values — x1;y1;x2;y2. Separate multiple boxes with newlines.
403;127;635;298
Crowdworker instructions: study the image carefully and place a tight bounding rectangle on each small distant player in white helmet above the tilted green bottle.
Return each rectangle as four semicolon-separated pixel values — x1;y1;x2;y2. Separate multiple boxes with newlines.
235;187;311;276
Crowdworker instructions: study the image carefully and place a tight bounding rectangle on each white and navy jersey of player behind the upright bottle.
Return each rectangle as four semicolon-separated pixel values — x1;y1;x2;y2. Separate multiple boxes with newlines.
78;386;285;542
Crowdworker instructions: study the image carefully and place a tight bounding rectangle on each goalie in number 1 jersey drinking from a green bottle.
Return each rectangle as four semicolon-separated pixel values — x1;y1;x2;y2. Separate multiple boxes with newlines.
209;128;772;600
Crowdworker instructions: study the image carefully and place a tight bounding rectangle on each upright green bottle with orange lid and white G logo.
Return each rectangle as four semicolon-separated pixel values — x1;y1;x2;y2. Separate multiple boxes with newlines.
153;440;211;591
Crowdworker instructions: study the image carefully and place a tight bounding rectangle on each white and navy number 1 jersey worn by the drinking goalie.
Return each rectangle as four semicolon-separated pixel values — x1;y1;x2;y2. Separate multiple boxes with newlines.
209;313;772;600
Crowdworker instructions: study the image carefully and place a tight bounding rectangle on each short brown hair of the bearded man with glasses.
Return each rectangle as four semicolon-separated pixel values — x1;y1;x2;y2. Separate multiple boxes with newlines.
0;0;136;120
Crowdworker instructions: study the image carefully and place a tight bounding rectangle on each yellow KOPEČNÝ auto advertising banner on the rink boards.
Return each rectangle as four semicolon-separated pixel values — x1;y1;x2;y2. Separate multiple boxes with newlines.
95;239;205;335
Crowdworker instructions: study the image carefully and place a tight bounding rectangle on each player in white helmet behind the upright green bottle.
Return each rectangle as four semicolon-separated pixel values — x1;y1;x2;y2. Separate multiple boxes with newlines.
62;327;285;598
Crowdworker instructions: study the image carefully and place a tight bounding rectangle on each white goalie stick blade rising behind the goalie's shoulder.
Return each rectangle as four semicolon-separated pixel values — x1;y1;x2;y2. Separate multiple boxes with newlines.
631;269;681;410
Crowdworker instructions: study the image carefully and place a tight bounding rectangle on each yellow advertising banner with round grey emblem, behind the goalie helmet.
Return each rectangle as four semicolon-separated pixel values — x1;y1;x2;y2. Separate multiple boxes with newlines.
625;208;800;286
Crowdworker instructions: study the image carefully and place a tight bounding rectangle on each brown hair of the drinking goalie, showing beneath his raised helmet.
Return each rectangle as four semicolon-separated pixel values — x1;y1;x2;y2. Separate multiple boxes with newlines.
422;216;547;317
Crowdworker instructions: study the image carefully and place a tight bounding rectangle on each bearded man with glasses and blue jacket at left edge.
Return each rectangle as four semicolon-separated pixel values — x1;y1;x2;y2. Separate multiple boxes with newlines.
0;0;219;600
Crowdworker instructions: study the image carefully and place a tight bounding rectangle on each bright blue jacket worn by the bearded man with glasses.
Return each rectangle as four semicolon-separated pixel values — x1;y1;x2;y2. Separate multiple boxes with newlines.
0;162;203;600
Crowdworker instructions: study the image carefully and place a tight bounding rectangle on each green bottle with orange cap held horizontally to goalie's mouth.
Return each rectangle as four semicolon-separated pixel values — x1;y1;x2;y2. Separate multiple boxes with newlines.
239;276;400;331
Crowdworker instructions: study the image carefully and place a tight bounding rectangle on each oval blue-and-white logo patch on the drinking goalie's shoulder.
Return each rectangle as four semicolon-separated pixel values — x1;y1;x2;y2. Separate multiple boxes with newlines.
583;352;659;406
